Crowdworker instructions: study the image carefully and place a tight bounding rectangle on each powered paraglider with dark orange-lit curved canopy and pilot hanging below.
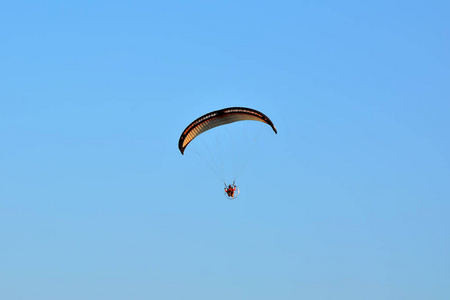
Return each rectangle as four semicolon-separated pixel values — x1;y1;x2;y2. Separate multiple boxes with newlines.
178;107;277;199
